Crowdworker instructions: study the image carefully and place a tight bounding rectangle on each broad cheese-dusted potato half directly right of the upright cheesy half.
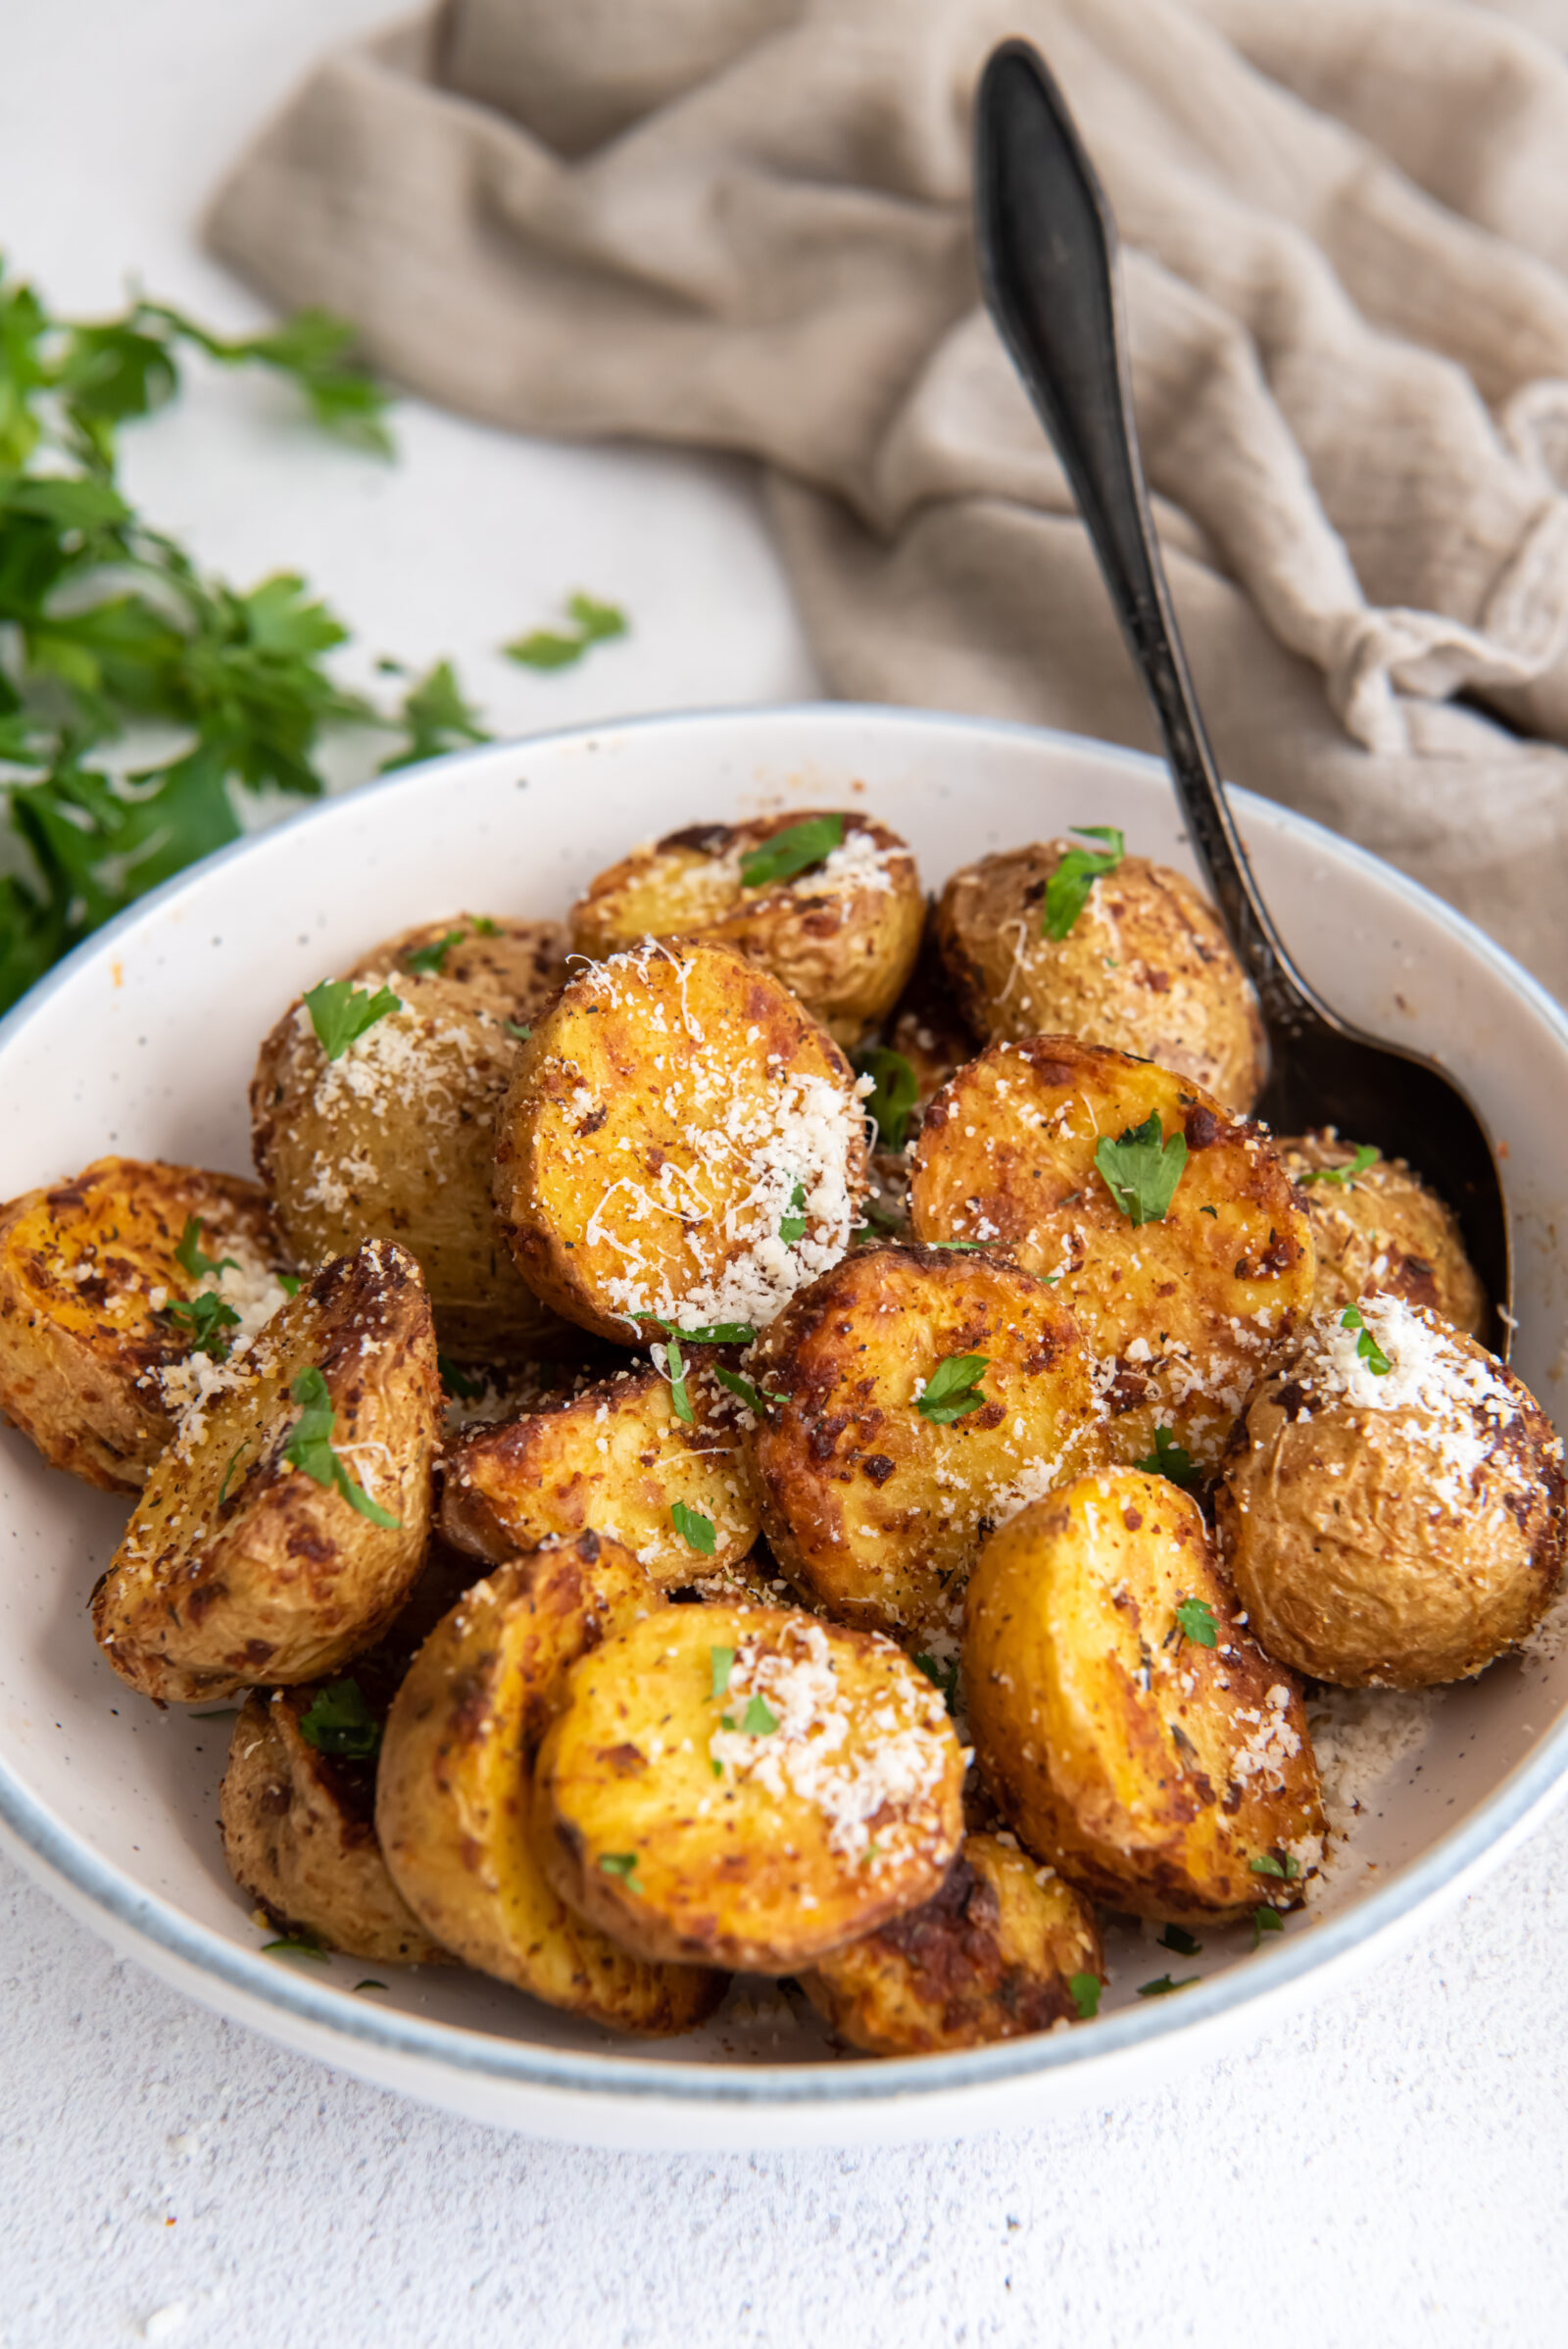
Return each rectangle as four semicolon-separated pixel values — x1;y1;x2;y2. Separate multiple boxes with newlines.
910;1036;1312;1471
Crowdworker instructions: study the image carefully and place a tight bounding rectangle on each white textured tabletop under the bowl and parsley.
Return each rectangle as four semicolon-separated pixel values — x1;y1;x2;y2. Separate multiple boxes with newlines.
0;0;1568;2349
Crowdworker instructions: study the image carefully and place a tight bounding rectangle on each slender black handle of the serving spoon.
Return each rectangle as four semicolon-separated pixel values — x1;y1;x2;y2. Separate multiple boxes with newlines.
974;40;1314;1029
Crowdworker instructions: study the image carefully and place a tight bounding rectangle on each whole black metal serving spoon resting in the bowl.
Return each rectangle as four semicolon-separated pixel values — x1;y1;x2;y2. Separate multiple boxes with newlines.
974;40;1514;1360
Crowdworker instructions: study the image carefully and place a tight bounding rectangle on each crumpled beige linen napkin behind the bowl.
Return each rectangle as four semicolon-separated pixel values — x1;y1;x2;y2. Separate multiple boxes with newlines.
209;0;1568;994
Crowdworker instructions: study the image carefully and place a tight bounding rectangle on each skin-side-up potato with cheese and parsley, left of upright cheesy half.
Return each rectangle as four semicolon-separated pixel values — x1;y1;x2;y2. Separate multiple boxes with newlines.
251;970;559;1362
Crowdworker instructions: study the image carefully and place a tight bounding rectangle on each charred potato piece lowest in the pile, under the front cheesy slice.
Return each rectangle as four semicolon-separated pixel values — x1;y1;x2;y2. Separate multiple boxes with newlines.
801;1835;1105;2055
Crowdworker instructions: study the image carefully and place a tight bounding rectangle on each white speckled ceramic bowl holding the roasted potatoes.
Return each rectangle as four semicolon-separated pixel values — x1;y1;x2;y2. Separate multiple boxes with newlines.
0;705;1568;2149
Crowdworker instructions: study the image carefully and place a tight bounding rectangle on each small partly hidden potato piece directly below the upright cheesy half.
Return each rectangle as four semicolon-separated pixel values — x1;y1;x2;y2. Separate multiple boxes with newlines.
441;1346;759;1584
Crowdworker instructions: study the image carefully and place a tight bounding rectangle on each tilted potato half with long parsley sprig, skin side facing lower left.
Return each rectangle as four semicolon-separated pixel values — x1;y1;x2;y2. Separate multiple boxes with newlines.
91;1241;441;1703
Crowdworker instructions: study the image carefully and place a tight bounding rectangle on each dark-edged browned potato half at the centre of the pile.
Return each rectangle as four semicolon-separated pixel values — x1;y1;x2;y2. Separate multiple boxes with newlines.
747;1248;1101;1635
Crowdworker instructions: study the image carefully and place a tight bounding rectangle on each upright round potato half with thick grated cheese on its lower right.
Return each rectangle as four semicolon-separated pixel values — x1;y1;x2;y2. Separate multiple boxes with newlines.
495;945;866;1344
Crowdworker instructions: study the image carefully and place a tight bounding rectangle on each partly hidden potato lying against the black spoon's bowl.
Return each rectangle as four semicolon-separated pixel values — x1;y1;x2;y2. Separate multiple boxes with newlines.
1275;1135;1486;1337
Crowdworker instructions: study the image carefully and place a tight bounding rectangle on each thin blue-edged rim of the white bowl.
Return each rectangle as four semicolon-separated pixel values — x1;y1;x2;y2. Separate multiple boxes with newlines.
0;703;1568;2107
